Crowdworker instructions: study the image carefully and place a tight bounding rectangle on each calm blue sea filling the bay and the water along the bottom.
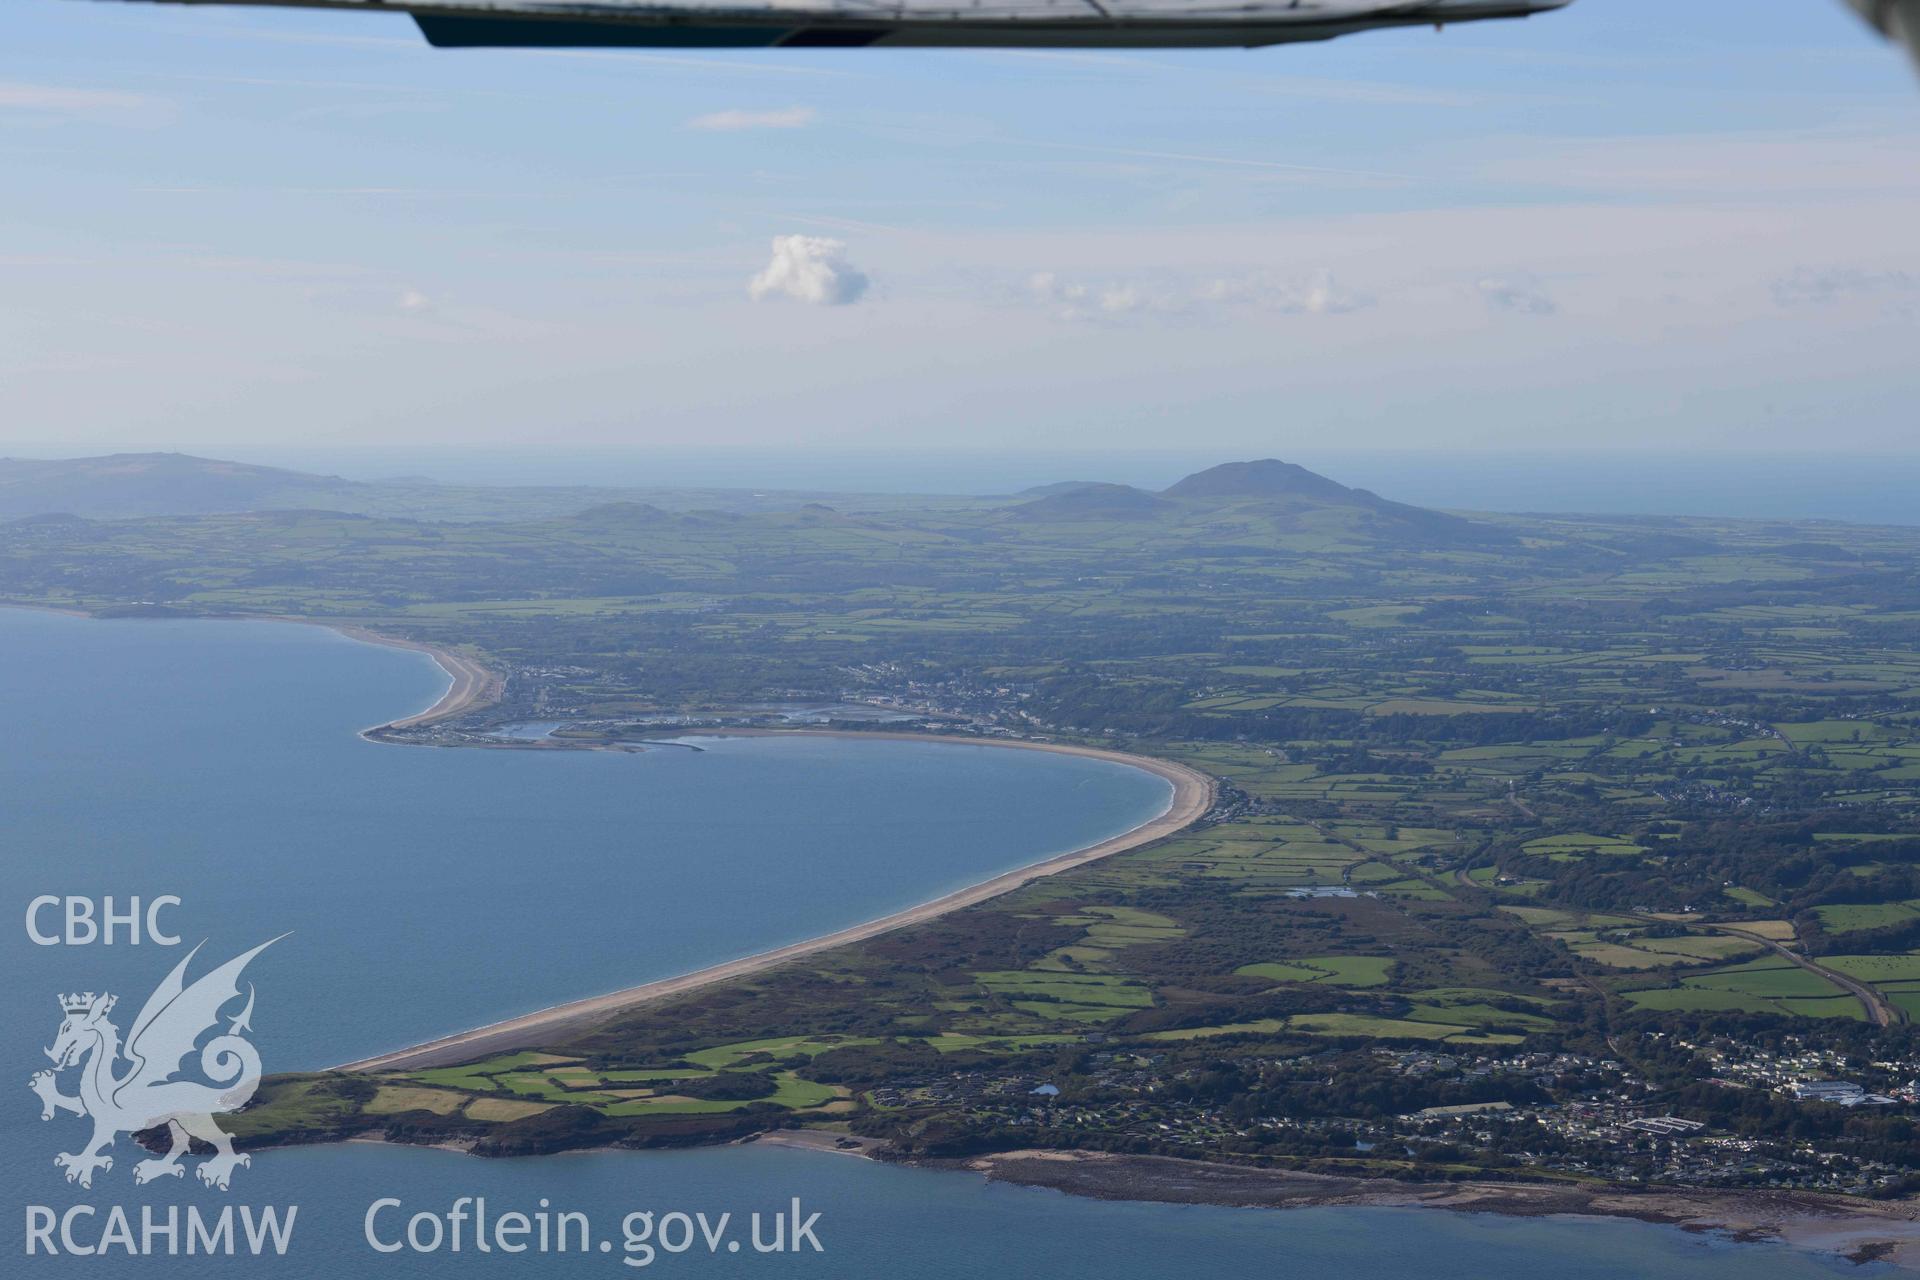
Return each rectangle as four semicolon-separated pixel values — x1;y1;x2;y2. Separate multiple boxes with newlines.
0;610;1878;1280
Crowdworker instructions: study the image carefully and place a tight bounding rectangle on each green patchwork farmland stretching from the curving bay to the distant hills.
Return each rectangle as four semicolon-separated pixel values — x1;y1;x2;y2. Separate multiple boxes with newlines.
22;461;1920;1178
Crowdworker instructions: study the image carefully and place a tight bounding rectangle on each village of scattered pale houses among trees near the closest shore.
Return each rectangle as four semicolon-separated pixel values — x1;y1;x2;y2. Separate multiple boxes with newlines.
864;1040;1920;1196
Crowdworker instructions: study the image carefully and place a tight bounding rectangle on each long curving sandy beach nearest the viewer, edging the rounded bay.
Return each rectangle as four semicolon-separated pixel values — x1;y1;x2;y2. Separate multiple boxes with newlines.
334;729;1213;1071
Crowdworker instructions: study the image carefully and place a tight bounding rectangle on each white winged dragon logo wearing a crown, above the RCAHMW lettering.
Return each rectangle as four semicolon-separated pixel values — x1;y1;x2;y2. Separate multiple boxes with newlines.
29;935;286;1192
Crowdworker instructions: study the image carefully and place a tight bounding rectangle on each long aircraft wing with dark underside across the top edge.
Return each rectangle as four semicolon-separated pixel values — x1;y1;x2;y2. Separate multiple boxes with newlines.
97;0;1571;48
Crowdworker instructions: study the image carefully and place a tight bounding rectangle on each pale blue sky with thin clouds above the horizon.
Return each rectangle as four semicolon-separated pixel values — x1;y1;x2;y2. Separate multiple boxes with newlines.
0;0;1920;457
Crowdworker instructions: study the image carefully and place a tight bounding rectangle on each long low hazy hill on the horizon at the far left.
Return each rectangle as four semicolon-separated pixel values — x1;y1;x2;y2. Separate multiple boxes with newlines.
0;453;372;520
